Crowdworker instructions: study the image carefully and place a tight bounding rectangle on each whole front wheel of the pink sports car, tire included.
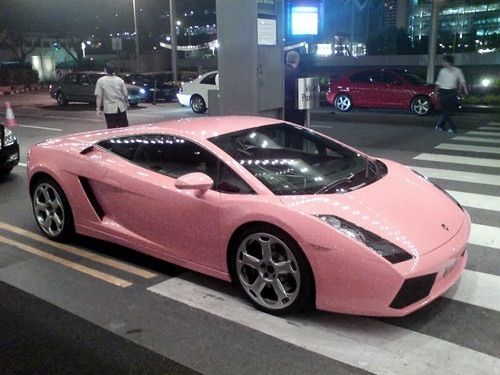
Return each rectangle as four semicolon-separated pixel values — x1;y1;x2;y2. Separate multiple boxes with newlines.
230;225;314;315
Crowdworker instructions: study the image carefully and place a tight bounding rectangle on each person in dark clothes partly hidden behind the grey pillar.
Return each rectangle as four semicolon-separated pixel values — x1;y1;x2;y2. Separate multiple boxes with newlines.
285;51;306;125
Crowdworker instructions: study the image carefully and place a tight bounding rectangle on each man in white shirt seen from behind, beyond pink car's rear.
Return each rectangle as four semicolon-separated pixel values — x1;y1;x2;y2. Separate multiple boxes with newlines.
95;64;128;129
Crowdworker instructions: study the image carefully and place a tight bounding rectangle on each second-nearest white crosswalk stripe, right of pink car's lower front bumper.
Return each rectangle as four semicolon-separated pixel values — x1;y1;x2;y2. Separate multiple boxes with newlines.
444;270;500;311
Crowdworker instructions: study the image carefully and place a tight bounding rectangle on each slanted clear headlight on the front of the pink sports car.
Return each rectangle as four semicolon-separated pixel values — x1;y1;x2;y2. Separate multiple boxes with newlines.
318;215;413;263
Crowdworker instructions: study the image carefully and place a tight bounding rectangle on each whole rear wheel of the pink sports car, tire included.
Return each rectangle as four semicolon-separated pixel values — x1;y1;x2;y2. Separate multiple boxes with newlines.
31;176;74;241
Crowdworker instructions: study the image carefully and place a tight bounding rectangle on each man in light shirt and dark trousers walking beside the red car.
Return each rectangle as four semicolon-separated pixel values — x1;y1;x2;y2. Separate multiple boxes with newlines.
436;55;469;133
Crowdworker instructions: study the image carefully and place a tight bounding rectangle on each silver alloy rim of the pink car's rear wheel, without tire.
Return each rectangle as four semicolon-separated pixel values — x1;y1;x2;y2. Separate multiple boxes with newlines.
33;183;65;237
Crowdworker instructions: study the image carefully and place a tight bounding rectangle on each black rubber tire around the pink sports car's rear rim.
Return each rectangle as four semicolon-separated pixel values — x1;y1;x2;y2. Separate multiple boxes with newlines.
31;176;75;241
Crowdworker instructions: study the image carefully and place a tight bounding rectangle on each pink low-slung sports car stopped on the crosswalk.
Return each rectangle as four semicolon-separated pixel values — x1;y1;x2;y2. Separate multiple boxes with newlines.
28;117;470;316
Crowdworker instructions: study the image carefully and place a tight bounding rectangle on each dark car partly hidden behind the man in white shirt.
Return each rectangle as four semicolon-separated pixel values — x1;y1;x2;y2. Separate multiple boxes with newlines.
49;72;146;106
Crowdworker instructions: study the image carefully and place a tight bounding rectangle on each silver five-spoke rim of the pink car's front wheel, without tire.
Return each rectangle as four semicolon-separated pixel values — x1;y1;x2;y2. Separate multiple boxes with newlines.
236;232;301;310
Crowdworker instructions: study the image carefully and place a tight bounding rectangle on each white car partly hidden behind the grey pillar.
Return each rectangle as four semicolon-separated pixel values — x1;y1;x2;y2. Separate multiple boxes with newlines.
177;71;219;113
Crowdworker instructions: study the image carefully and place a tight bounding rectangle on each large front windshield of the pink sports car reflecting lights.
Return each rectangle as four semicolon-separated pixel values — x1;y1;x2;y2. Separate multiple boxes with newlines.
209;124;385;195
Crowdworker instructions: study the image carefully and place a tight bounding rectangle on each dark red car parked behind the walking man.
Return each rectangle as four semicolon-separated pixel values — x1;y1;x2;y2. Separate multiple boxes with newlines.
326;69;441;116
